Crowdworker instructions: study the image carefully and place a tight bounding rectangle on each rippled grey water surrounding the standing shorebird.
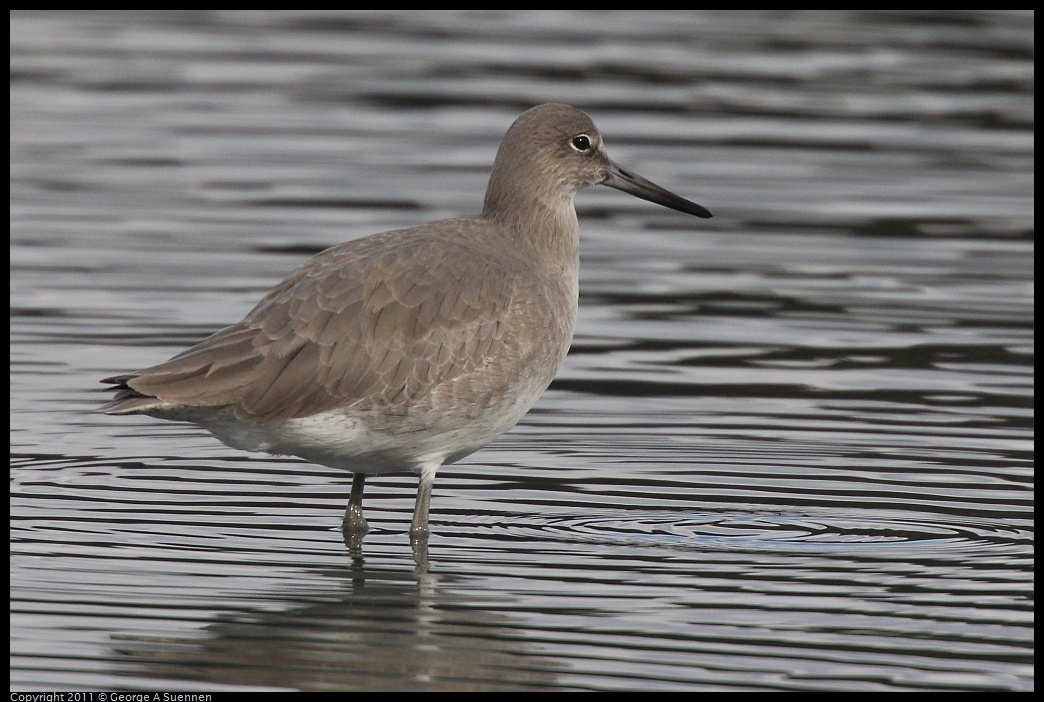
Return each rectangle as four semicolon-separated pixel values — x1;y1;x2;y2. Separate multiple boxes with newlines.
10;10;1034;691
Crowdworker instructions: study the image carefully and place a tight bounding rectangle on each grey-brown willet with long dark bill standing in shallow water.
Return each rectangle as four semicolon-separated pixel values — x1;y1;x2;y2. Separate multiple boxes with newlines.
100;104;711;540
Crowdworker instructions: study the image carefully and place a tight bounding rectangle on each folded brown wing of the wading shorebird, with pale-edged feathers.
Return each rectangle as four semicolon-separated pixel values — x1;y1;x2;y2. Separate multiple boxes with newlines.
103;220;547;424
